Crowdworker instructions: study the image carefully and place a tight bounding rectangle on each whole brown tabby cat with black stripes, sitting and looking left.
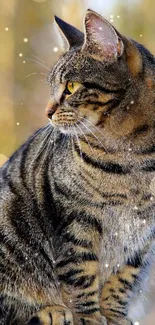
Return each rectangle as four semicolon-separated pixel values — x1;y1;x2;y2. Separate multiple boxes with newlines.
0;10;155;325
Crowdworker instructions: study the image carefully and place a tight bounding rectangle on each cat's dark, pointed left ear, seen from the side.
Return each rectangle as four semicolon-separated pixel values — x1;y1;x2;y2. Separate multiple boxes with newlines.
54;16;84;52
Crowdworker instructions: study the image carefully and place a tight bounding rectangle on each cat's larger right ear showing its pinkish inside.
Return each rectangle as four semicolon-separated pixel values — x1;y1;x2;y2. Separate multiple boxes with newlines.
82;9;124;62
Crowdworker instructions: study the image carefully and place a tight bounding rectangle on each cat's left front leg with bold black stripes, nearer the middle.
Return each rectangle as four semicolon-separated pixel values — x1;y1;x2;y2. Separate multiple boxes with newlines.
57;214;101;325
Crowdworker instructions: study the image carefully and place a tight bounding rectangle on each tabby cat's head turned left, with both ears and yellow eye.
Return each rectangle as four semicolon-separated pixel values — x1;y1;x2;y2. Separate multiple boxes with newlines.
46;10;154;147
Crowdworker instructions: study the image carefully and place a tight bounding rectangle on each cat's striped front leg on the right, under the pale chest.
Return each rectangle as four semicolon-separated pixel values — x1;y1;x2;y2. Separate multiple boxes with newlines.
100;265;140;325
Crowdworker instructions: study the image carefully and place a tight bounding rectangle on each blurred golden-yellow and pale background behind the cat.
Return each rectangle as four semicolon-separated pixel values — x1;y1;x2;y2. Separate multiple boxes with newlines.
0;0;155;325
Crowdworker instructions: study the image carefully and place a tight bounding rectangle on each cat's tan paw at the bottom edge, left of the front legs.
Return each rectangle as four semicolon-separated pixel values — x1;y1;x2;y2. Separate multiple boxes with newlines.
28;306;74;325
